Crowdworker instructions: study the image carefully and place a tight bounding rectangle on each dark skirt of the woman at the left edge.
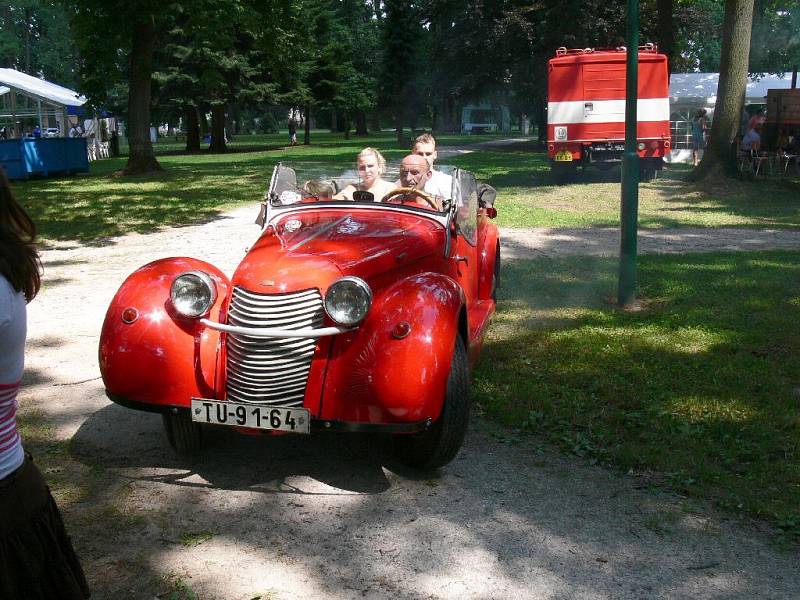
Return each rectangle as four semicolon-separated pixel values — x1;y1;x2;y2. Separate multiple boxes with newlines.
0;456;89;600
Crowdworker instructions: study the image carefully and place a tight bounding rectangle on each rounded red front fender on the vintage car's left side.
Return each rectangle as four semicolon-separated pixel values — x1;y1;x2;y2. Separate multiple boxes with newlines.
99;257;231;410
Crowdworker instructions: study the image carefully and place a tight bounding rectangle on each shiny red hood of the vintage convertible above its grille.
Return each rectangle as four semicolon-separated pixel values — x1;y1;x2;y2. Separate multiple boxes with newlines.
233;208;445;289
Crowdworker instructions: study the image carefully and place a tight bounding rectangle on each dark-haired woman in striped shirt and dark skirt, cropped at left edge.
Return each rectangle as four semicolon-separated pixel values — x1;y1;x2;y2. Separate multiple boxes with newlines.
0;168;90;600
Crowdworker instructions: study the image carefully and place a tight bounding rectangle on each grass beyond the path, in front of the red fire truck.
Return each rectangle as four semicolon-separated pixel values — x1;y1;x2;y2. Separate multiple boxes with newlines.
448;147;800;228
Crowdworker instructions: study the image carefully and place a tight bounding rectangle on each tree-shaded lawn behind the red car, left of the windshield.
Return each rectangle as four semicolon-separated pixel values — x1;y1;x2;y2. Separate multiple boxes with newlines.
13;132;504;242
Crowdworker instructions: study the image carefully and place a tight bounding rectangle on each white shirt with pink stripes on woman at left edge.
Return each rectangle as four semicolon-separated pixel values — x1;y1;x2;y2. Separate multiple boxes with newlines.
0;275;26;479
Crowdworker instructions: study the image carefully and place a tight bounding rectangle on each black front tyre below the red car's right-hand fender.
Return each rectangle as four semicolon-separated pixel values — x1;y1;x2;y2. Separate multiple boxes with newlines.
395;336;469;470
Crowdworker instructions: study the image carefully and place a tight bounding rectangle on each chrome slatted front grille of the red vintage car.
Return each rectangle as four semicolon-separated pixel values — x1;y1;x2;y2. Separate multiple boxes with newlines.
227;286;323;407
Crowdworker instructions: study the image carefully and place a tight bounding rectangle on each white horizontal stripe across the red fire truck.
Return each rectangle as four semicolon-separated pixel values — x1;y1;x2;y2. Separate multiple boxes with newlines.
547;98;669;125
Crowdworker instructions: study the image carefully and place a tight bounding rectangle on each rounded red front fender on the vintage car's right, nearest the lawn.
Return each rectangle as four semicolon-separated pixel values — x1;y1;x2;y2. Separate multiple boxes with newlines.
322;273;466;423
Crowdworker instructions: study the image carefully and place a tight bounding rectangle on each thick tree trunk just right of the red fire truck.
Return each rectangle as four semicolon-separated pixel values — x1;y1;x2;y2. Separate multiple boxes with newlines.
692;0;753;181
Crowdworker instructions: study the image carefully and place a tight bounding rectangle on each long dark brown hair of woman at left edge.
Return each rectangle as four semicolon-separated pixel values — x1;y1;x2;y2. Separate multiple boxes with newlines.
0;168;42;302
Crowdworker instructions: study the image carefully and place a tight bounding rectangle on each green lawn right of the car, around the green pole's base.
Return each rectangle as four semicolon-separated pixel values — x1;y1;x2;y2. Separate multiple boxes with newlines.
474;252;800;536
